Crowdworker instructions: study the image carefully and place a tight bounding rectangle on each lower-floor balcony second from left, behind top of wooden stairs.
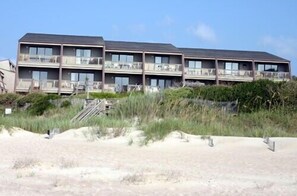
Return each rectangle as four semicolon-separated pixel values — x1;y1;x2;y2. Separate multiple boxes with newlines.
61;80;102;93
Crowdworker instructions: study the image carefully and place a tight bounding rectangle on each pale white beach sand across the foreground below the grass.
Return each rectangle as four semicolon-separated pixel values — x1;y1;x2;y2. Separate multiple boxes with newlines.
0;128;297;196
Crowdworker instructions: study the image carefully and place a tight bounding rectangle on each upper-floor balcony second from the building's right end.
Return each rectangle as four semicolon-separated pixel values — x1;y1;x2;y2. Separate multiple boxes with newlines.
218;69;253;81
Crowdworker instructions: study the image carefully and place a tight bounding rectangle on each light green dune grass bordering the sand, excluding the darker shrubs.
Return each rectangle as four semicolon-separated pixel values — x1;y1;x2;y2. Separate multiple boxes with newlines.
0;89;297;141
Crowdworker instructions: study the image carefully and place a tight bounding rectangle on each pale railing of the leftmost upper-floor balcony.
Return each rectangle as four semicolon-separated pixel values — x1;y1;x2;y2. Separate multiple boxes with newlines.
19;54;60;63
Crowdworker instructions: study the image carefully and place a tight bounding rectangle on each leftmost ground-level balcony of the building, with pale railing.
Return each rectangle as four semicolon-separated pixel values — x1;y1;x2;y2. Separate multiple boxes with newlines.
16;79;59;93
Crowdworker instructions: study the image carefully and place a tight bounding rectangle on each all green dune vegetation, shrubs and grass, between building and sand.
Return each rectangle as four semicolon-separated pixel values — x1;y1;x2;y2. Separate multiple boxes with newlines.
0;80;297;143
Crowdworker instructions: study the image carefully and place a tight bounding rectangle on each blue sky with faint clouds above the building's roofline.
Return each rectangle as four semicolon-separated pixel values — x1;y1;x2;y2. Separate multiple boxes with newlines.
0;0;297;75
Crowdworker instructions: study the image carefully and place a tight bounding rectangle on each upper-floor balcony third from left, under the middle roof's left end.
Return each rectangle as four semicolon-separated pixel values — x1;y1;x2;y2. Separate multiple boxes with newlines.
105;61;142;74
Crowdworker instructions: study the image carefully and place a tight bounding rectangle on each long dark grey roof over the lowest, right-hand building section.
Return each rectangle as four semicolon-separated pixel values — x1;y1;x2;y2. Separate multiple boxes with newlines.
179;48;289;62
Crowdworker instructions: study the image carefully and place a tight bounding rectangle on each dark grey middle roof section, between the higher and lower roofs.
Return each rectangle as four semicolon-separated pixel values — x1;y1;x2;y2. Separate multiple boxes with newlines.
105;41;181;54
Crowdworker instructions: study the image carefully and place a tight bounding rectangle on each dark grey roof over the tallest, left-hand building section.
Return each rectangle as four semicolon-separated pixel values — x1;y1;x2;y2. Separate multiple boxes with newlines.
19;33;104;46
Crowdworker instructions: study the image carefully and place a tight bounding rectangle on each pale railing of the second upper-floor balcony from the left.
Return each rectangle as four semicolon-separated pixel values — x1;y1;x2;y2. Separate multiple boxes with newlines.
63;56;102;65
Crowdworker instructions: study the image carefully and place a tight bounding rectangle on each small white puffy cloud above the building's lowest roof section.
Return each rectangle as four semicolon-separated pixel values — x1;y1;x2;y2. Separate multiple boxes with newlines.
189;23;217;43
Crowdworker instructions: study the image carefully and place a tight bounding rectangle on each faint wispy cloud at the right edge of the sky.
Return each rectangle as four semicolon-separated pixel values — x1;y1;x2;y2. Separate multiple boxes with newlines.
261;35;297;57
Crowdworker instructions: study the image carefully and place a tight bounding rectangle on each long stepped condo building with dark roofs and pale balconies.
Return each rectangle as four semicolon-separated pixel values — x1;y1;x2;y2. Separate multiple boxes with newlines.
14;33;291;95
